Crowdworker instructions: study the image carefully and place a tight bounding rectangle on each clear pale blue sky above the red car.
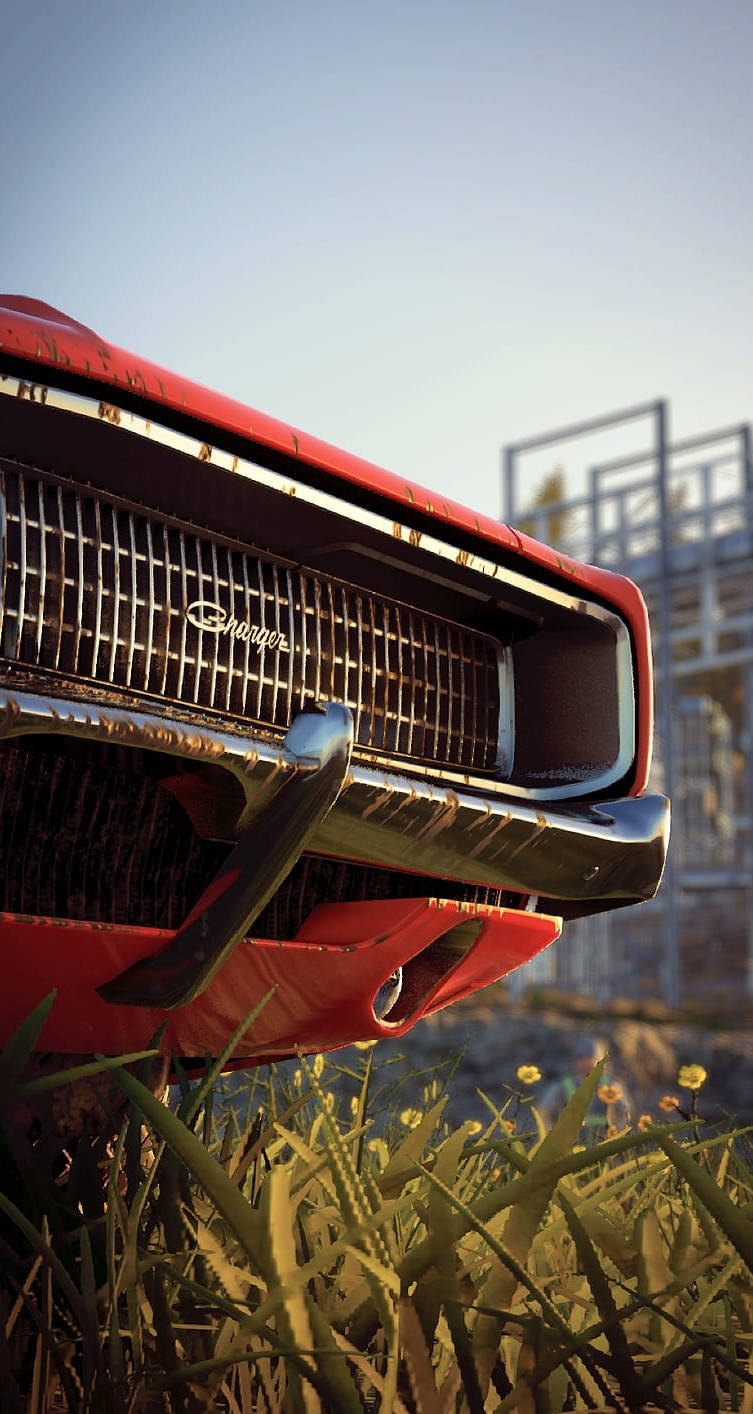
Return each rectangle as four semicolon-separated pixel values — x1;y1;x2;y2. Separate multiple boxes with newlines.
0;0;753;515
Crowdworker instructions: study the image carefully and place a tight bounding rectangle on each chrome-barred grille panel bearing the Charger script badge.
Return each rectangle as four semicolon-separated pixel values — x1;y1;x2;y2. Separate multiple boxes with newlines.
0;464;500;771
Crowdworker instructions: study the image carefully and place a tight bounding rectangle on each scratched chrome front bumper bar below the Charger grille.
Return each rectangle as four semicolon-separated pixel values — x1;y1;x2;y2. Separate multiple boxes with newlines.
0;690;670;905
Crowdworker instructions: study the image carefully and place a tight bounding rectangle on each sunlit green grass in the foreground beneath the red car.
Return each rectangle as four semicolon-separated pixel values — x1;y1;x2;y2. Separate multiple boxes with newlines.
0;1015;753;1414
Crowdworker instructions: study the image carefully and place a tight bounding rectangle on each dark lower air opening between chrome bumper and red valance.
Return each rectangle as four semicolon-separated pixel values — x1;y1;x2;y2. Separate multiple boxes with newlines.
0;738;523;939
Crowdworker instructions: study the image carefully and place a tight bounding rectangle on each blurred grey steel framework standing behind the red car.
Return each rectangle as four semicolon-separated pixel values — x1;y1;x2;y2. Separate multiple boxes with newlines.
503;400;753;1005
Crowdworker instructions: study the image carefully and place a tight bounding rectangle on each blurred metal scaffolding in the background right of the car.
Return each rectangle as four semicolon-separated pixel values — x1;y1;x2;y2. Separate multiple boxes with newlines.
503;400;753;1005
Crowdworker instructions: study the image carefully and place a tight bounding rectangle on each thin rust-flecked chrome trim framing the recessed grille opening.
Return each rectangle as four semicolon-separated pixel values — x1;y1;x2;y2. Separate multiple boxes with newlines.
0;375;636;800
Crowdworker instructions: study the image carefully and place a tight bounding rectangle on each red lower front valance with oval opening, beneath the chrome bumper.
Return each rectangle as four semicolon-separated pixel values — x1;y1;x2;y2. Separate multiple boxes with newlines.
0;898;561;1062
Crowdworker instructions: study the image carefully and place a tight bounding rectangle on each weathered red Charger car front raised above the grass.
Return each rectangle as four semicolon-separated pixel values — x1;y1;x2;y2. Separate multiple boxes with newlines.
0;296;668;1061
